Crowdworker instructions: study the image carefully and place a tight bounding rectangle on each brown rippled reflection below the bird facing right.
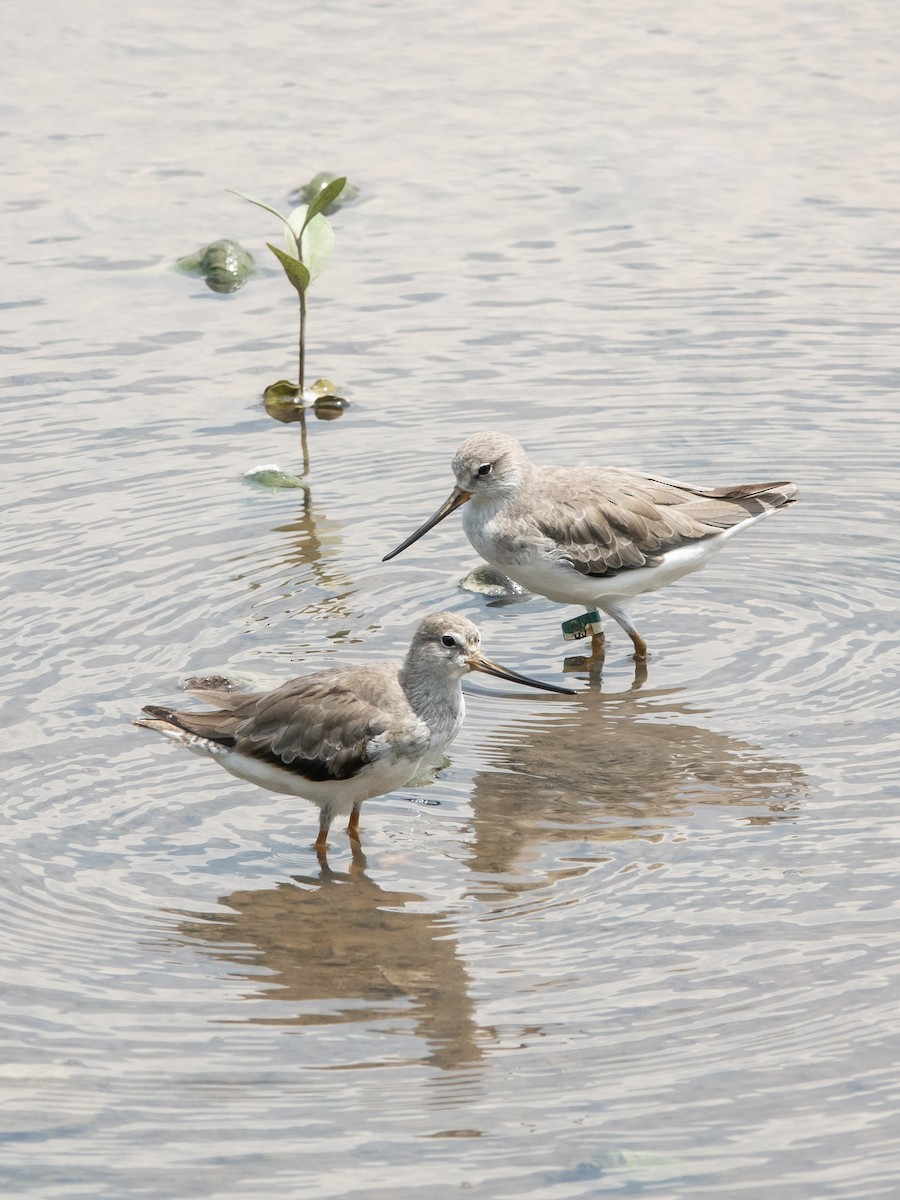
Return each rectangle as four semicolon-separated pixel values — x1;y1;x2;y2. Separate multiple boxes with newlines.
178;851;490;1069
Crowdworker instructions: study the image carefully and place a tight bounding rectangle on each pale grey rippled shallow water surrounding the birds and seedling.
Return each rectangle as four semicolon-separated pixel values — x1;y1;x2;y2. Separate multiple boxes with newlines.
0;0;900;1200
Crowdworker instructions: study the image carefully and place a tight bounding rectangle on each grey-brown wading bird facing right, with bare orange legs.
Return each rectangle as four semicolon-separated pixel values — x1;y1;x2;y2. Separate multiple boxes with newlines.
134;612;574;856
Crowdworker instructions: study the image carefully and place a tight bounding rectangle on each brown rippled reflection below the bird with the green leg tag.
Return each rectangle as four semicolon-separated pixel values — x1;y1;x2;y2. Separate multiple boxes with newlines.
469;689;806;874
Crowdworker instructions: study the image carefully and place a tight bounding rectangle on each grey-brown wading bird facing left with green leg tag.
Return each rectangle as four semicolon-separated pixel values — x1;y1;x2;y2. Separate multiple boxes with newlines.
383;433;797;662
